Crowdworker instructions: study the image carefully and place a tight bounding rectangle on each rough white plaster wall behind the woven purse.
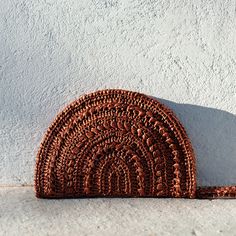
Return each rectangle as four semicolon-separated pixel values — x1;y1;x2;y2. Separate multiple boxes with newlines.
0;0;236;185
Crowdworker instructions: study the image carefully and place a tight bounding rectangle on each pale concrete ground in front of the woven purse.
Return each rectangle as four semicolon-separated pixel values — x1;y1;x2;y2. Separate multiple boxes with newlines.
0;187;236;236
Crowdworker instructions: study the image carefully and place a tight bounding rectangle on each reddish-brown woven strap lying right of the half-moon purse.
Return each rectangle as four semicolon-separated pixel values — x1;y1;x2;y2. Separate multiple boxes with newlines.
197;186;236;199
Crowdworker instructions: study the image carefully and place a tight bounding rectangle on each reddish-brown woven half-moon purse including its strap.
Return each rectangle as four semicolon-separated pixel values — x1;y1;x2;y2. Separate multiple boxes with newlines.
35;89;236;198
